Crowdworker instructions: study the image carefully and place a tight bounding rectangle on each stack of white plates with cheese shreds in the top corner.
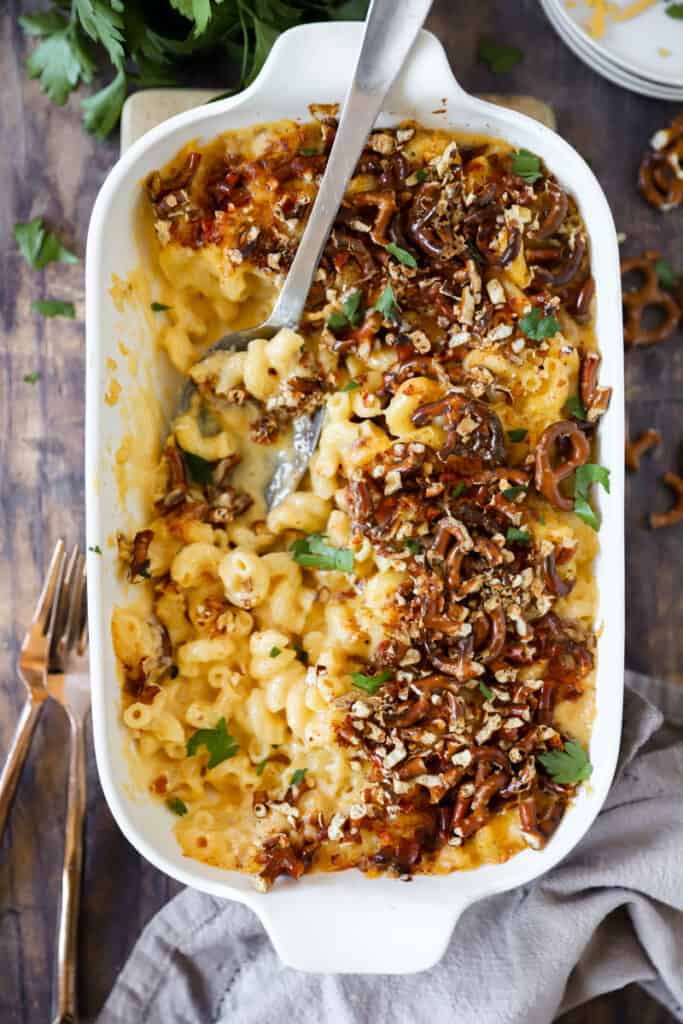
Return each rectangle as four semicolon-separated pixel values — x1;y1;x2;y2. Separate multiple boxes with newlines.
541;0;683;101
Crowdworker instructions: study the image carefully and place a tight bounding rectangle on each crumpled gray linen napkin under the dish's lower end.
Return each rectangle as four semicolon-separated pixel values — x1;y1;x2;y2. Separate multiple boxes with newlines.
98;673;683;1024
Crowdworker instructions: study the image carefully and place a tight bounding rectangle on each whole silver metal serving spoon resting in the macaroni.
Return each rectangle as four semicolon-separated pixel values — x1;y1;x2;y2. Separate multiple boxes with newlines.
181;0;432;509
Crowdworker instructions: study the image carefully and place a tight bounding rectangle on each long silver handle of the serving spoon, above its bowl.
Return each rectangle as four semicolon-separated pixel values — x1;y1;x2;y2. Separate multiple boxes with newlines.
268;0;432;328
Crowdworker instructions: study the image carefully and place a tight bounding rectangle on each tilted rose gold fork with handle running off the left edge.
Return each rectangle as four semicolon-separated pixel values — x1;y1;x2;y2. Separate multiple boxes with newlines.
0;541;65;840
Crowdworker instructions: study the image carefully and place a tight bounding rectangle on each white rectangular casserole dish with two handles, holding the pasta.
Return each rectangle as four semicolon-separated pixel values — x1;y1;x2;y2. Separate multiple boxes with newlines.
86;23;624;974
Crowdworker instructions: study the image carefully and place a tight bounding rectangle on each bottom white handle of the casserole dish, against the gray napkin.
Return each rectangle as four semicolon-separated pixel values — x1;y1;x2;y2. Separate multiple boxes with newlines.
256;901;469;974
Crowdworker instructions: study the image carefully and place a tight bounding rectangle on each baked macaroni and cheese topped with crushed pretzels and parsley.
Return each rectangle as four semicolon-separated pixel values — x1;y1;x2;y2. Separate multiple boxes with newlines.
113;108;609;888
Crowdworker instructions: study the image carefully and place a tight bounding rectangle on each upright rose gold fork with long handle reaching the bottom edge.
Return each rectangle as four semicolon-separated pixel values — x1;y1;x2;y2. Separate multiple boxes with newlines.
47;548;90;1024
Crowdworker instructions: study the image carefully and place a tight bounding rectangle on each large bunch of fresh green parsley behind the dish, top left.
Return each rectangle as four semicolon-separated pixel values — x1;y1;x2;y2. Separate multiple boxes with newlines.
18;0;368;138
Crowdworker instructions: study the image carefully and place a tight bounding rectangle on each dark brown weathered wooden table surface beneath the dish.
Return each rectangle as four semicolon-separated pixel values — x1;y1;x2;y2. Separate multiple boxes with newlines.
0;0;683;1024
